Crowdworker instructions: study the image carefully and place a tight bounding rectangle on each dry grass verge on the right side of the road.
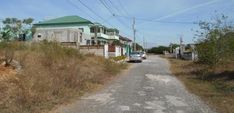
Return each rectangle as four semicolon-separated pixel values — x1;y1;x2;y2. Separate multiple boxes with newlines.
167;58;234;113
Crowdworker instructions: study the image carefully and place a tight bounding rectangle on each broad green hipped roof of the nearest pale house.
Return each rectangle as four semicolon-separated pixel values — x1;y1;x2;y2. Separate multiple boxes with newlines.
35;16;92;25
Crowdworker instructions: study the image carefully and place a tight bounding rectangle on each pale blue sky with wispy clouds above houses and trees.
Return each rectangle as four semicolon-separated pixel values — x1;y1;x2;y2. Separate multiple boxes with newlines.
0;0;234;47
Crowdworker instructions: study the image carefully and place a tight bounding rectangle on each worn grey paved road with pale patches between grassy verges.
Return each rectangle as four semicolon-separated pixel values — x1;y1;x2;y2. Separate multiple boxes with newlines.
52;56;213;113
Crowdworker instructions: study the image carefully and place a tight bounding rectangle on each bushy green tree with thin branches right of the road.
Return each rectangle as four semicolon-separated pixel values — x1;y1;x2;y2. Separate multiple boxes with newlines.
196;15;234;67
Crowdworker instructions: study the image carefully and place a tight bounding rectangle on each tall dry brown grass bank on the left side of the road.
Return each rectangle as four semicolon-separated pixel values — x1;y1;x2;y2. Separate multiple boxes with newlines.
0;41;127;113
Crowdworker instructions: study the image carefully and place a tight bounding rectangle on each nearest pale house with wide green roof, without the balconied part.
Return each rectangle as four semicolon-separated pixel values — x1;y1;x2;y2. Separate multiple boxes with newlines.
33;16;93;45
